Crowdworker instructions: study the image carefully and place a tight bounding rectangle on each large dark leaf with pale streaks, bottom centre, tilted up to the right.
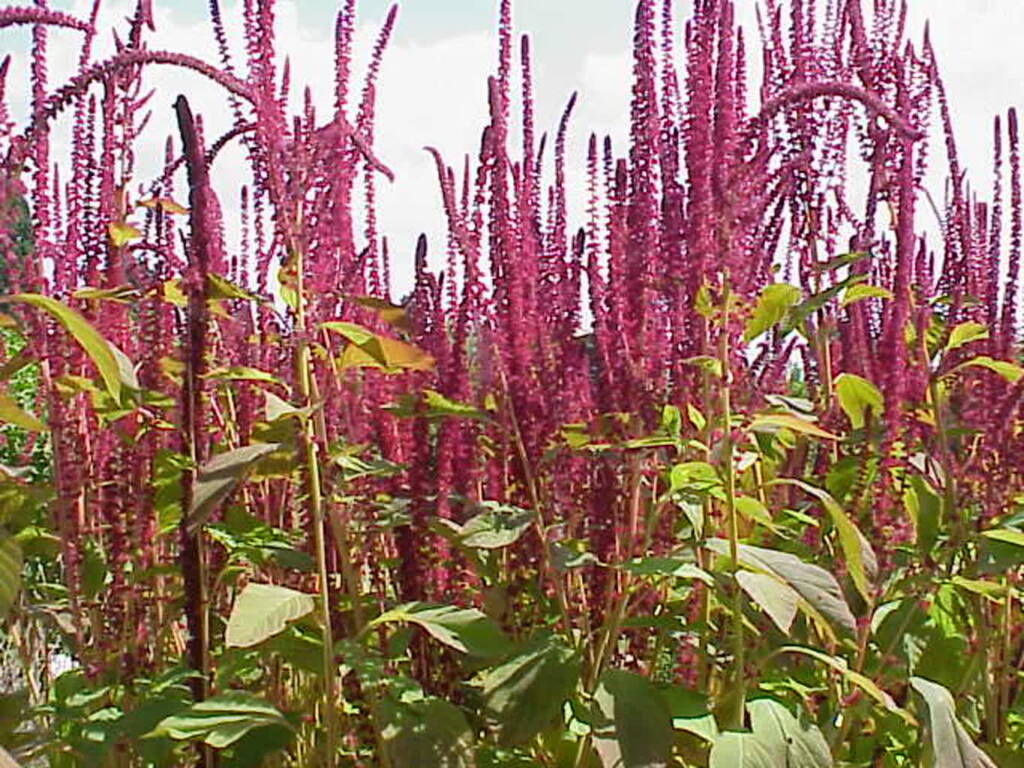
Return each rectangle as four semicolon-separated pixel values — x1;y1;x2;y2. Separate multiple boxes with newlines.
480;637;580;746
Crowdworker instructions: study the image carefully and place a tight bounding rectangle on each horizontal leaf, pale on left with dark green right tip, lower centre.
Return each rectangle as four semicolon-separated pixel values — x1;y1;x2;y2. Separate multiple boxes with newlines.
367;602;510;658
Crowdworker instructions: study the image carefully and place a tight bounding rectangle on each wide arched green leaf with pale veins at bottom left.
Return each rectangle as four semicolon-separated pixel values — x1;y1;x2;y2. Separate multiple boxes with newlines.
146;691;292;750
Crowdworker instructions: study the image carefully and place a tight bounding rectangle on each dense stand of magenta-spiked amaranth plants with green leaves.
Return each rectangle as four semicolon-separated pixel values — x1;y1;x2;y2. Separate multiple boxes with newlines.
0;0;1024;768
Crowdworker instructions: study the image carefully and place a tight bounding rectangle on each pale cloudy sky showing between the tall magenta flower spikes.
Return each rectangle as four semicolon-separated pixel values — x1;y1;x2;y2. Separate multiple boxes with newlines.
0;0;1024;295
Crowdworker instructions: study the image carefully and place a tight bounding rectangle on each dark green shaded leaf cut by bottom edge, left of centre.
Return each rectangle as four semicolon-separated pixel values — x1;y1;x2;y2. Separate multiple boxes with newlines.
376;695;475;768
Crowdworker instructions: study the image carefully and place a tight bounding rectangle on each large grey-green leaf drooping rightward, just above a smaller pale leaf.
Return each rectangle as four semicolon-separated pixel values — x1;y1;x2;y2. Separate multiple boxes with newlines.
705;539;857;635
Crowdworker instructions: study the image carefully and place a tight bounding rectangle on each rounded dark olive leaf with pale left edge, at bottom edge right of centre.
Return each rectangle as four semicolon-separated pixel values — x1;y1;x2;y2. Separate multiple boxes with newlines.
592;670;673;768
